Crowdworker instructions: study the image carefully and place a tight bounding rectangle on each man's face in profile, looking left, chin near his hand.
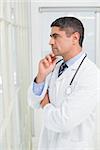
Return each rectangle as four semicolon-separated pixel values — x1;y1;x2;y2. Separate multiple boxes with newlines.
49;26;79;57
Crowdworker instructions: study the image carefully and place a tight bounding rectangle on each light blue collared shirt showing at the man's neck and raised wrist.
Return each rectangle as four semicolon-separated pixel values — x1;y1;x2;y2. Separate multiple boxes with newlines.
33;51;84;96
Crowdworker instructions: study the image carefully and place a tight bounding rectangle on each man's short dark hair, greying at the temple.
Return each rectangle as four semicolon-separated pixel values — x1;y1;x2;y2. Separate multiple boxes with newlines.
51;17;84;47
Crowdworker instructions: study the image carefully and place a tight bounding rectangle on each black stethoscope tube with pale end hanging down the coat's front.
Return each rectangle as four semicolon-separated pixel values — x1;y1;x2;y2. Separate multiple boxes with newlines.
65;54;87;95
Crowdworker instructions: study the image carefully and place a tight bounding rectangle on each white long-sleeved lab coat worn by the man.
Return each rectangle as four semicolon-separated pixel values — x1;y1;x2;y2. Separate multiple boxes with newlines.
28;54;100;150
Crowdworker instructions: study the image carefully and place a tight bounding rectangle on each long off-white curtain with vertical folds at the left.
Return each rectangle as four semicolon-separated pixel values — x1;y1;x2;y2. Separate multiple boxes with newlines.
0;0;31;150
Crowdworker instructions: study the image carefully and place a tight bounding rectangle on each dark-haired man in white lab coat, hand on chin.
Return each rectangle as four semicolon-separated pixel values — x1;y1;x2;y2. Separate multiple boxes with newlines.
28;17;100;150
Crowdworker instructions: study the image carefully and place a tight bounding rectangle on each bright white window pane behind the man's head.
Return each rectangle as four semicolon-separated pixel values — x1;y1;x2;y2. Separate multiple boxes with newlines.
41;9;96;62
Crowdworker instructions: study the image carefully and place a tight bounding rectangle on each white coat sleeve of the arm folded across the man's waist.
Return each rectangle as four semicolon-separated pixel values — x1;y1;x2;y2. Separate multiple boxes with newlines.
43;69;100;132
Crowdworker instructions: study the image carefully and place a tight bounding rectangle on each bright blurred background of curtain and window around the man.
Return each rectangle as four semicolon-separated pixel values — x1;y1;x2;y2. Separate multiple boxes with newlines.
0;0;100;150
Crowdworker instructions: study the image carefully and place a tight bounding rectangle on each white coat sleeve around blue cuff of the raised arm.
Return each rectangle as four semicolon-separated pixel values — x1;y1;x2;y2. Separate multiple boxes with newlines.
27;73;51;109
